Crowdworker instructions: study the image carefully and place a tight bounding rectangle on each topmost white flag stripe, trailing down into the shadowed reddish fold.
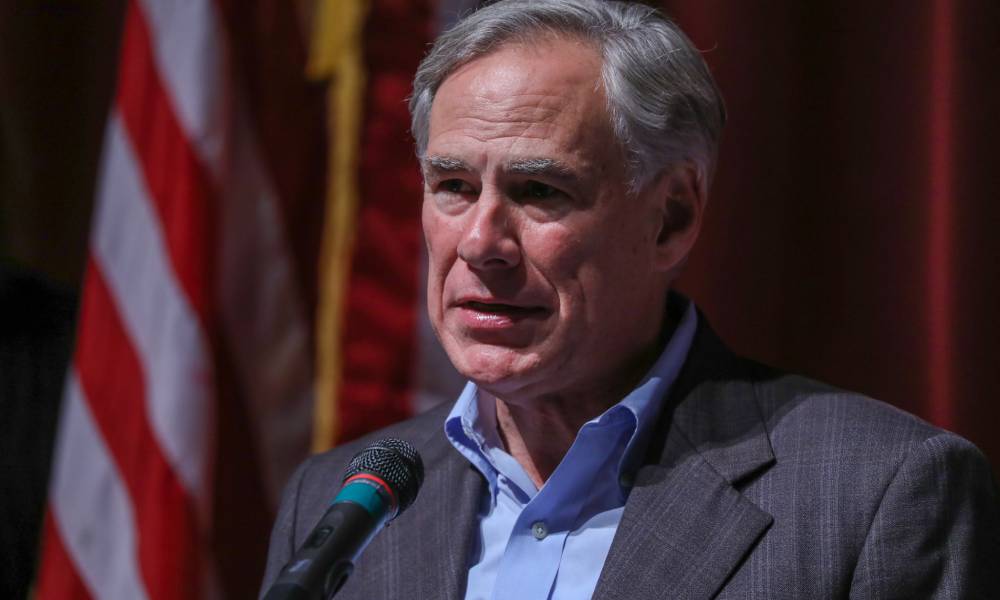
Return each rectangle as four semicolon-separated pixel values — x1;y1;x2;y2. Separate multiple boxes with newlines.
141;0;313;507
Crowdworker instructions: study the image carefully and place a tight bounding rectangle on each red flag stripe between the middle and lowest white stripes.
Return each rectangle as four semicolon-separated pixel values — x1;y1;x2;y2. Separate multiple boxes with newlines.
75;260;202;600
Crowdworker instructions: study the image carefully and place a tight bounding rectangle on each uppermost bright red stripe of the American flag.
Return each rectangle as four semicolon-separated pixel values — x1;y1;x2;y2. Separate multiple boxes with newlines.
117;0;216;324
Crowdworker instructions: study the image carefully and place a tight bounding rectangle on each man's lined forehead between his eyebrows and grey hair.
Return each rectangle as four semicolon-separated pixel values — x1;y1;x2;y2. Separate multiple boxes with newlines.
427;38;613;171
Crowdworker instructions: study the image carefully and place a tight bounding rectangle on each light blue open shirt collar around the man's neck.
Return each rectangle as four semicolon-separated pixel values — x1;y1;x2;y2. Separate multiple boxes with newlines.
444;294;698;497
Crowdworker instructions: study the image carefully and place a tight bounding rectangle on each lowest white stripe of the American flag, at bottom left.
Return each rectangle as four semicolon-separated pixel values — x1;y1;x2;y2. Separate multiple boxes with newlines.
50;369;147;600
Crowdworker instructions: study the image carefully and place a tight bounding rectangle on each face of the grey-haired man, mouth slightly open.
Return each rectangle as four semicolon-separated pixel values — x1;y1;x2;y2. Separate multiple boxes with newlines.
423;40;680;402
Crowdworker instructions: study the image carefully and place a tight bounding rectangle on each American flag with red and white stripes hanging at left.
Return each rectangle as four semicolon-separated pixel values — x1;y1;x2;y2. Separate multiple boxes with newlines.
37;0;322;599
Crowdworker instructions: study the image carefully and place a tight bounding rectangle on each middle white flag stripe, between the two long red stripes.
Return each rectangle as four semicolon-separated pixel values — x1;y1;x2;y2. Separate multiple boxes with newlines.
91;110;215;527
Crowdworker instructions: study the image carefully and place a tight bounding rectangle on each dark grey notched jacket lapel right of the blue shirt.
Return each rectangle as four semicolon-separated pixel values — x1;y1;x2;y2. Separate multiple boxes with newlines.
593;315;774;600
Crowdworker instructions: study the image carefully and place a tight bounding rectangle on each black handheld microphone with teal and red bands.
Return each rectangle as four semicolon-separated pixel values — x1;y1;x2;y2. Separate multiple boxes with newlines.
264;438;424;600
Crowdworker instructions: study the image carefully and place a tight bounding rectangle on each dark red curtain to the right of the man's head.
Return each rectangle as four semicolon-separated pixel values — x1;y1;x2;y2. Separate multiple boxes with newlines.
664;0;1000;472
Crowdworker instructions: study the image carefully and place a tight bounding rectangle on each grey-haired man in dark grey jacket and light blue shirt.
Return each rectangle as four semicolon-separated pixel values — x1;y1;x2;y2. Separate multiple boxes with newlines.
265;0;1000;599
